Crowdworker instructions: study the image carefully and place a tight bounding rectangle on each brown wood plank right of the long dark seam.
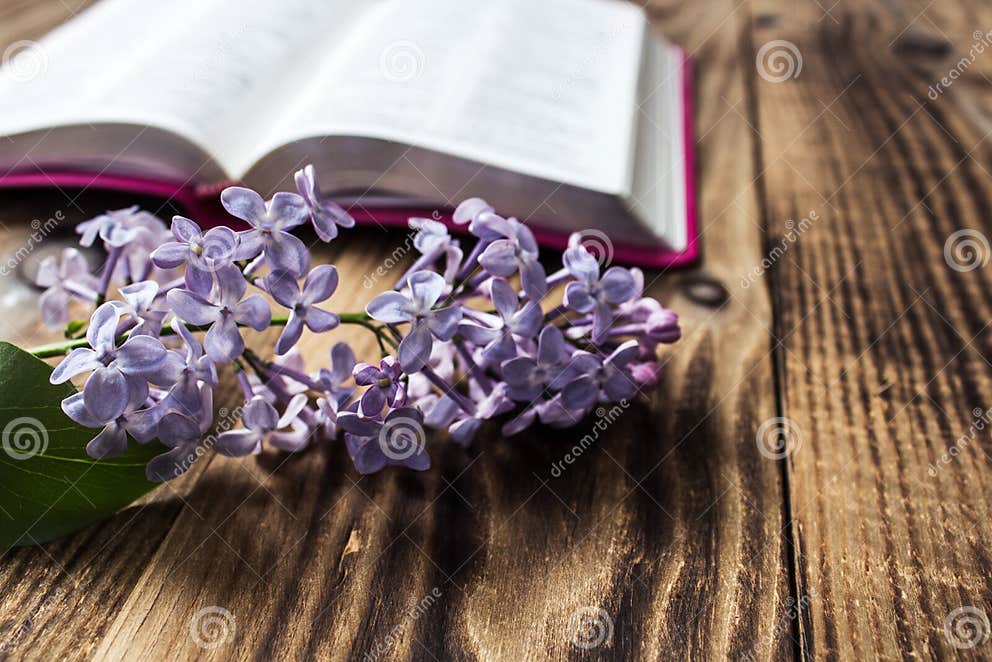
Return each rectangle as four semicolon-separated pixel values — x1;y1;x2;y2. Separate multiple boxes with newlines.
754;0;992;659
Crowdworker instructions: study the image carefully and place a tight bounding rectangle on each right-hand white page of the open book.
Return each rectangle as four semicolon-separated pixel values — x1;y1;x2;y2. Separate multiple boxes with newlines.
238;0;645;193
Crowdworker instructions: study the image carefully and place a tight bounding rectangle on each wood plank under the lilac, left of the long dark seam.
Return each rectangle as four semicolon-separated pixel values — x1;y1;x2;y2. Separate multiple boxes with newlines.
0;0;795;659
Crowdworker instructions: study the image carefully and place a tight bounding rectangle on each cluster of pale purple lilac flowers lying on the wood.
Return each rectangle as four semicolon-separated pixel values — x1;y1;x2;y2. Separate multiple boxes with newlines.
38;166;679;481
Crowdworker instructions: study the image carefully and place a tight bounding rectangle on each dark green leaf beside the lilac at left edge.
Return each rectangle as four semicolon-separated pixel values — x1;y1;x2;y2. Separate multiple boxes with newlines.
0;342;165;549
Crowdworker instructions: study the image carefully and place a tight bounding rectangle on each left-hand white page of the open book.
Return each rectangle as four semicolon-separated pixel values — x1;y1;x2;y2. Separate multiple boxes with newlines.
0;0;360;176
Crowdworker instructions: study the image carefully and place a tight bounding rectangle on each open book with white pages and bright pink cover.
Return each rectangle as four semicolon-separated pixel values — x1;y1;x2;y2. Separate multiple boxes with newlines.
0;0;697;266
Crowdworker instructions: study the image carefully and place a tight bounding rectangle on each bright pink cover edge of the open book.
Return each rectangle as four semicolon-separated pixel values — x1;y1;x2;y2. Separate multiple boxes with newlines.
0;51;699;269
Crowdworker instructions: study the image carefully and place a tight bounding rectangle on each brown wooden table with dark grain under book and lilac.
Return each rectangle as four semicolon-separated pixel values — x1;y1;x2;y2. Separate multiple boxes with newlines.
0;0;992;660
